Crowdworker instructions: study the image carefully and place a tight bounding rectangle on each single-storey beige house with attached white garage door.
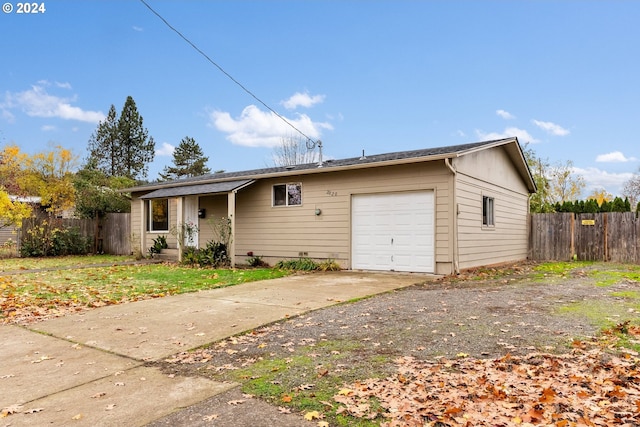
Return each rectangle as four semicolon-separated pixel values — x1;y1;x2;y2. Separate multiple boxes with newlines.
126;138;536;274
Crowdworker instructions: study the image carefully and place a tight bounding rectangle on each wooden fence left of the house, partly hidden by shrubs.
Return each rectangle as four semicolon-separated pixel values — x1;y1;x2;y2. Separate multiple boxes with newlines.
18;213;131;255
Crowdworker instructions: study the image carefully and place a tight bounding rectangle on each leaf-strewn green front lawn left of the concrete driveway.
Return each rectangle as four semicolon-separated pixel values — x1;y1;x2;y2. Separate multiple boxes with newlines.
0;257;288;323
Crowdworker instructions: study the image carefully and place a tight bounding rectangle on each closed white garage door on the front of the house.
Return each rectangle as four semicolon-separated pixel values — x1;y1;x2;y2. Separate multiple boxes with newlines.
351;191;435;273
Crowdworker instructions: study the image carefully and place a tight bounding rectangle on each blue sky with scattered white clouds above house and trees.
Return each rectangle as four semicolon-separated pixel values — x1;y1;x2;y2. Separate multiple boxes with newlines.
0;0;640;196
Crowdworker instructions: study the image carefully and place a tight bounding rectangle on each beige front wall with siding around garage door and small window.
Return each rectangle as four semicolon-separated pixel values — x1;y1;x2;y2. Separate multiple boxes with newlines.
235;161;453;273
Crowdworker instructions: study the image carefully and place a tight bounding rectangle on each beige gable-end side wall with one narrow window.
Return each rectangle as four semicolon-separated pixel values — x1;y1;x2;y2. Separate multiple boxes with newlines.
454;148;529;269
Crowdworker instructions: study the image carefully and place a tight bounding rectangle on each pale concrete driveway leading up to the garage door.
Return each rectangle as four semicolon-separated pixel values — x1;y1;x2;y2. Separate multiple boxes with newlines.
0;272;430;427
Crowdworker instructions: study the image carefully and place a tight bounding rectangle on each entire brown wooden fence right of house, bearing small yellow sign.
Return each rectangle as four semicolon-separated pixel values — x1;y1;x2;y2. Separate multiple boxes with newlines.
529;212;640;264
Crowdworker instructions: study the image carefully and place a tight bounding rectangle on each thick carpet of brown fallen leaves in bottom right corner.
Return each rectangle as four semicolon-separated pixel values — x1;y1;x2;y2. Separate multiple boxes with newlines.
334;343;640;427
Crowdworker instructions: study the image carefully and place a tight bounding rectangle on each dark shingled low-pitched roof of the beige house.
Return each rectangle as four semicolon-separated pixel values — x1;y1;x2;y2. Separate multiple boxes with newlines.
122;138;536;198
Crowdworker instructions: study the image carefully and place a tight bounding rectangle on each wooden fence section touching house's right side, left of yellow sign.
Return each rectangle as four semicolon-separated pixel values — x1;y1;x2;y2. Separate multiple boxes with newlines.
529;213;573;261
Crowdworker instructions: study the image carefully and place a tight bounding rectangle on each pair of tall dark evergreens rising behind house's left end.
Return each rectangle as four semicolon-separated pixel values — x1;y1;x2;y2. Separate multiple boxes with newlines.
88;96;155;179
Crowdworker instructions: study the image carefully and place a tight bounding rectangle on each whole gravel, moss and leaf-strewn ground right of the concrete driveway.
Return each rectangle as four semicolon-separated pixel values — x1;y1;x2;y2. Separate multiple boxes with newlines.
153;263;640;427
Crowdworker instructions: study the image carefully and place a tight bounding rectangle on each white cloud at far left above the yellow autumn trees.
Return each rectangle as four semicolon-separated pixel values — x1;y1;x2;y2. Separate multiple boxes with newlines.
0;81;105;123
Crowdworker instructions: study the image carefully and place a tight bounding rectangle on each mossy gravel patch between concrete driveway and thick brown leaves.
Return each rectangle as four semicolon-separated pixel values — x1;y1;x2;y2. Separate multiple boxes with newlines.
146;266;640;426
